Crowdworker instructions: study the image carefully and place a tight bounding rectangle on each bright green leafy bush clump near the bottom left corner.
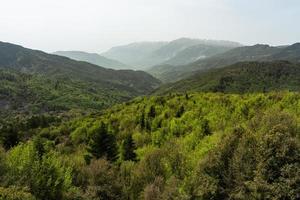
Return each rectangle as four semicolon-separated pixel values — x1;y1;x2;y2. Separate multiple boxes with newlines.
5;142;72;200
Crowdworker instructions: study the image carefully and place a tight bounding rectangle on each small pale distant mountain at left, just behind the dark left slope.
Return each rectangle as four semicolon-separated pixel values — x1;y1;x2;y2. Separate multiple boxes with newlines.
53;51;130;69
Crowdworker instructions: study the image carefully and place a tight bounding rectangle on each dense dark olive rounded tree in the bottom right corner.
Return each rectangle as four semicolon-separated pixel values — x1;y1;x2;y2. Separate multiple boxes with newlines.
250;124;300;200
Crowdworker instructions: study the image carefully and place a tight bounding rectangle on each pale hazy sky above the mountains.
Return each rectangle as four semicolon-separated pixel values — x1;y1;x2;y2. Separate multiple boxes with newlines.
0;0;300;52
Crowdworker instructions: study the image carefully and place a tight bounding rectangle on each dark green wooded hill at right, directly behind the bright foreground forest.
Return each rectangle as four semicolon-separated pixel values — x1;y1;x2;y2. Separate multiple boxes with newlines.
155;61;300;94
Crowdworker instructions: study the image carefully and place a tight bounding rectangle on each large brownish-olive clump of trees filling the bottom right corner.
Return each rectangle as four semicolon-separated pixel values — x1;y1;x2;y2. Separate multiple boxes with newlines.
190;112;300;199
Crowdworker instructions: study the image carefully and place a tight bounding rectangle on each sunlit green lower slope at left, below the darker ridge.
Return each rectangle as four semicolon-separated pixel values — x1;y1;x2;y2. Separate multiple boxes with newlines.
0;70;137;115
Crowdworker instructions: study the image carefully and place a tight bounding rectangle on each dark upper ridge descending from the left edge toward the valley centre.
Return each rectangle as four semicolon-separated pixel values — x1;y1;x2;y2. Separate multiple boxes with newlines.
0;42;159;95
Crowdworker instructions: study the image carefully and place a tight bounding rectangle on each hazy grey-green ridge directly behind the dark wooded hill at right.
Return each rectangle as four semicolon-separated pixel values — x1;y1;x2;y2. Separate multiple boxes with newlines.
147;44;300;82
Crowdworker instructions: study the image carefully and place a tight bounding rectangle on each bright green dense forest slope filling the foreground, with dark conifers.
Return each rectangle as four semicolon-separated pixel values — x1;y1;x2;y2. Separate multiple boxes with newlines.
0;91;300;200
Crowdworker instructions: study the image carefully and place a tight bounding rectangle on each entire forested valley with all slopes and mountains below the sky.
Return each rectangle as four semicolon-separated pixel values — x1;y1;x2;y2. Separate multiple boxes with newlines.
0;39;300;200
